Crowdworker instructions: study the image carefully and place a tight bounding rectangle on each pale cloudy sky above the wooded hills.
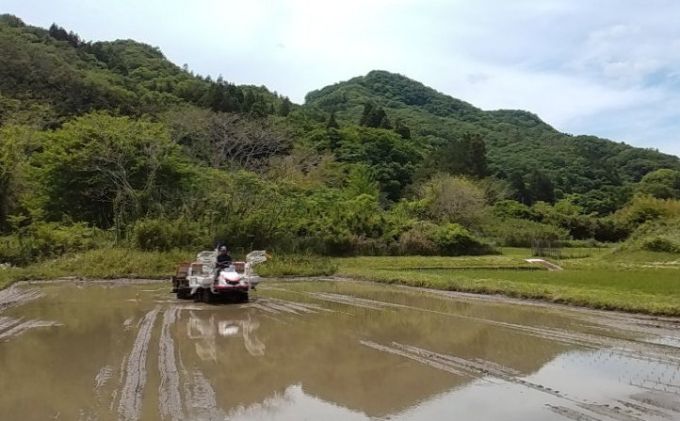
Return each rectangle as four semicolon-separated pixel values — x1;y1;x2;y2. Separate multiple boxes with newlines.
5;0;680;155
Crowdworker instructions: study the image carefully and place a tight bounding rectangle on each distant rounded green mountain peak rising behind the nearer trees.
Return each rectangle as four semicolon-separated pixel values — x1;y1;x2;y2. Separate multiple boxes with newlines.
306;71;680;203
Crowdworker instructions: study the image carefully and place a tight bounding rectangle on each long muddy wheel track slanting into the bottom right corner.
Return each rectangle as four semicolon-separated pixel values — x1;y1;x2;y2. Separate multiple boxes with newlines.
359;340;680;421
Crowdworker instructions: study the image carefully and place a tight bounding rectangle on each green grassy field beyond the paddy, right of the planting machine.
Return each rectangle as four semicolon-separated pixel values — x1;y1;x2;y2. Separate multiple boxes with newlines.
336;249;680;316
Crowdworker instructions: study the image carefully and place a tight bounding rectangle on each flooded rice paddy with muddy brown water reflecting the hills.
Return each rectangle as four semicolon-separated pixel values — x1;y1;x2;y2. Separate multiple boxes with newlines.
0;280;680;421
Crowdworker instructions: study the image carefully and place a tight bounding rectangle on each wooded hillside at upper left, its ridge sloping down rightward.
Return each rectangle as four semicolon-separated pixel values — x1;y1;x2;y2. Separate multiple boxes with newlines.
0;15;284;126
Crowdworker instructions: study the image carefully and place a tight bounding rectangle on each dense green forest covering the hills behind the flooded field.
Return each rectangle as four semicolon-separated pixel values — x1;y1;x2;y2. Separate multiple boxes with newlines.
0;15;680;264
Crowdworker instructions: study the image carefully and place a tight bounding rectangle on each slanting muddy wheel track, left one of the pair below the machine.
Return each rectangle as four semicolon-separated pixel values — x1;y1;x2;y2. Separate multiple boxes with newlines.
118;307;160;421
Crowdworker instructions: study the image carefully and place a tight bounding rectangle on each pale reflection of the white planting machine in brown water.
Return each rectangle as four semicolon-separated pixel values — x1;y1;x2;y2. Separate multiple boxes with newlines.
187;311;266;361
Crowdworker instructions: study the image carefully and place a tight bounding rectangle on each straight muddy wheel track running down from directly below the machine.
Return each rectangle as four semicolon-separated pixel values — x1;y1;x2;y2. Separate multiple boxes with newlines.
158;307;184;421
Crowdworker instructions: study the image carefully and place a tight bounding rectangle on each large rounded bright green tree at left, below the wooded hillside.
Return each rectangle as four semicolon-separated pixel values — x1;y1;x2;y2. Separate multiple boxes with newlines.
33;114;185;232
